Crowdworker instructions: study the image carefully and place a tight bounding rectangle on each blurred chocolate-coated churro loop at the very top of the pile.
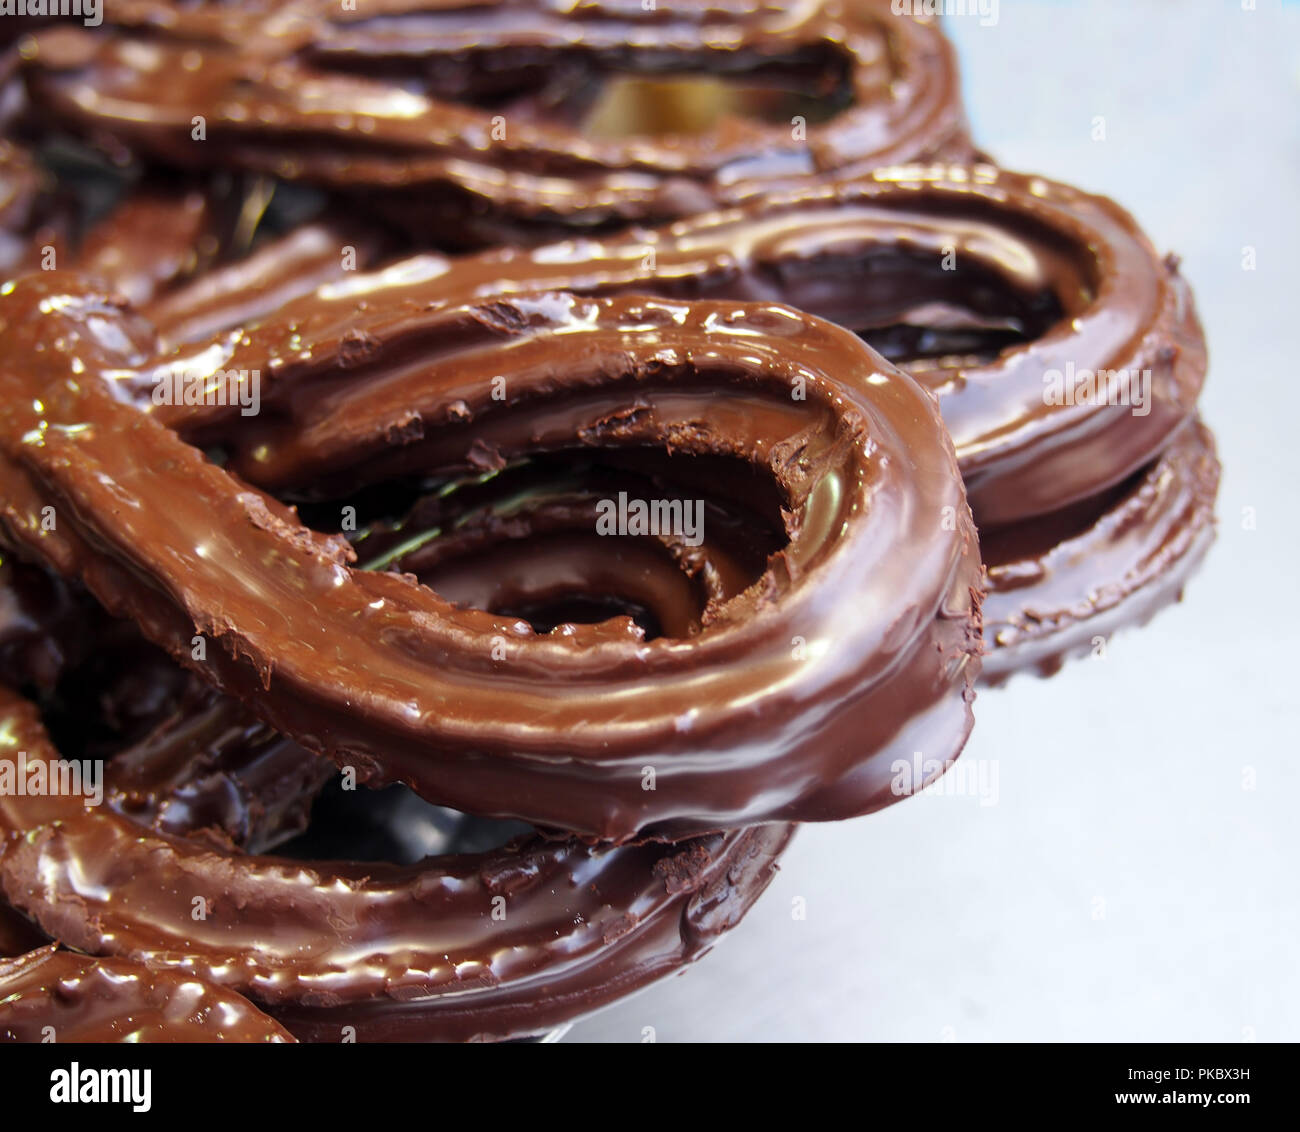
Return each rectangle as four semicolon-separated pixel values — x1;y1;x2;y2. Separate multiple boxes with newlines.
23;0;971;242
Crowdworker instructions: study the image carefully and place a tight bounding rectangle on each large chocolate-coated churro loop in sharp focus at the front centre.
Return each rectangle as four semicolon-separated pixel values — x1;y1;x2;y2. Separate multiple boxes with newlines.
0;274;980;840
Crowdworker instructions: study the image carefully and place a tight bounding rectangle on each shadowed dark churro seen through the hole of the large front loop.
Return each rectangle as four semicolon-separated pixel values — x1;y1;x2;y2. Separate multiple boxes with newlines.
366;452;785;638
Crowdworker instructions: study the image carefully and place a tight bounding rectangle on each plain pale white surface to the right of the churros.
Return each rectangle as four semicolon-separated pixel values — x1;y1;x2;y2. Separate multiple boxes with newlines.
567;0;1300;1041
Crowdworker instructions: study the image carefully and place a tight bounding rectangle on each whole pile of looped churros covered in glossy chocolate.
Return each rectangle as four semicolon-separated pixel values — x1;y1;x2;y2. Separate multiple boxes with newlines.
0;0;1218;1041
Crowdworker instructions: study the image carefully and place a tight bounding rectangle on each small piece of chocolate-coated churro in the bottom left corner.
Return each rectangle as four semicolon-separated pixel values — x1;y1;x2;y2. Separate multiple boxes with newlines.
0;946;294;1044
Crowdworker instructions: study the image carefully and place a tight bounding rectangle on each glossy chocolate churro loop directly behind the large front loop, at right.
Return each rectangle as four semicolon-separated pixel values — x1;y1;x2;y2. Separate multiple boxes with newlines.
157;165;1205;528
